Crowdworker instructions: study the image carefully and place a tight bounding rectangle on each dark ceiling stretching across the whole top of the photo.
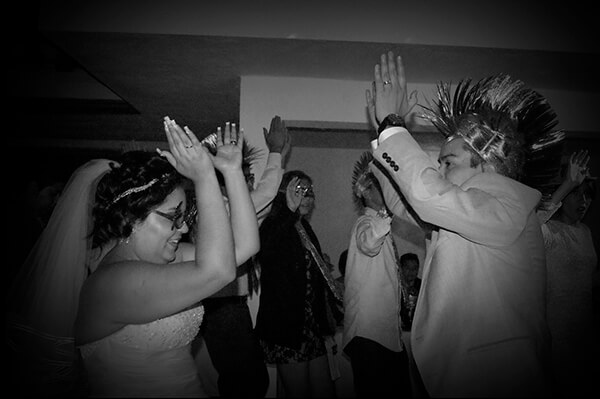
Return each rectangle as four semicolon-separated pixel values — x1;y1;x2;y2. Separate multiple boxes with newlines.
7;0;600;159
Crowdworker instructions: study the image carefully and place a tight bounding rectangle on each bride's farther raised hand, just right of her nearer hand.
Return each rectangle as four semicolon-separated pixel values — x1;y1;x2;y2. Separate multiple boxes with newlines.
212;122;244;173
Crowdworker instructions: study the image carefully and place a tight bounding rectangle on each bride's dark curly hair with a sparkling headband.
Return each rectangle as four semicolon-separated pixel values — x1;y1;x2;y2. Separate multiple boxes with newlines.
91;151;185;248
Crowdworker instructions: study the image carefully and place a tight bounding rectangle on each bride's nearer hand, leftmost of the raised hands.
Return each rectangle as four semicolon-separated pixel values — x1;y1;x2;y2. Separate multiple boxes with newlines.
157;116;214;181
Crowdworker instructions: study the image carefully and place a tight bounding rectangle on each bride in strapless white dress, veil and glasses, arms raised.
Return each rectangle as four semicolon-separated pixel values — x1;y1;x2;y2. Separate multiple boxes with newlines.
7;118;259;396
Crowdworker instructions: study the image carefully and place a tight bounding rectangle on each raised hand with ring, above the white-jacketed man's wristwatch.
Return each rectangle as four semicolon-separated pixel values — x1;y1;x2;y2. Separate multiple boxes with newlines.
366;51;417;126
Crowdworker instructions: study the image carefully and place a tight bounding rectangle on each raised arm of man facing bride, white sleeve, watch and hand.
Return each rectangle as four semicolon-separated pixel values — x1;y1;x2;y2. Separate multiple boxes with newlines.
372;53;539;245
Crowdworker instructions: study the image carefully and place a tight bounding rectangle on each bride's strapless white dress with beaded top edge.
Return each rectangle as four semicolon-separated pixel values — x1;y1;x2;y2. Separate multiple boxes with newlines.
79;306;206;397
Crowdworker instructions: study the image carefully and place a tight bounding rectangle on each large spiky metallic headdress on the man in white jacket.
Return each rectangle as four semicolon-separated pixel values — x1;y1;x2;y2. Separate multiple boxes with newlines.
421;74;564;197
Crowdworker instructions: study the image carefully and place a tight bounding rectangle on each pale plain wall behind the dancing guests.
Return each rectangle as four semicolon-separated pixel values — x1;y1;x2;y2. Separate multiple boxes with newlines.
240;75;600;276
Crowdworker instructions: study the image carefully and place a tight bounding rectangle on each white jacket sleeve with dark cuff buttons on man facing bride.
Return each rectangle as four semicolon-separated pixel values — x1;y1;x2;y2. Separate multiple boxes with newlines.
373;128;539;246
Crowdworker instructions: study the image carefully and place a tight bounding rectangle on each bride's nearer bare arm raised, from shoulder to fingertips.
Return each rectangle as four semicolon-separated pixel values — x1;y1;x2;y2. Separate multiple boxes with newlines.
76;118;236;336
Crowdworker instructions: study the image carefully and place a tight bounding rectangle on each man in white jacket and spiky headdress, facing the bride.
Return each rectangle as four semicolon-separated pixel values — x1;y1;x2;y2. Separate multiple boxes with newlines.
367;52;560;397
